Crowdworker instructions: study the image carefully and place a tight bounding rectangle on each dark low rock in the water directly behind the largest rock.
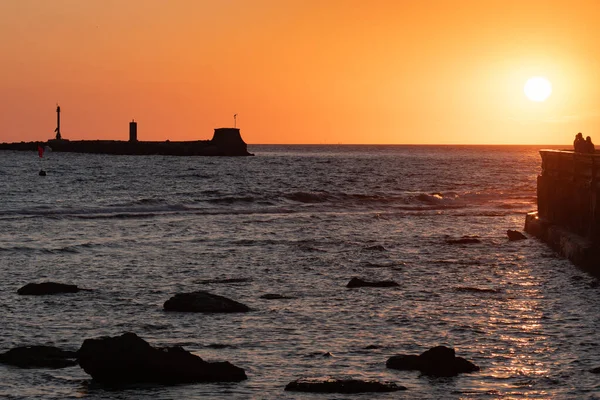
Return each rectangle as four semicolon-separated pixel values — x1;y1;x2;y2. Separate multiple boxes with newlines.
163;290;250;313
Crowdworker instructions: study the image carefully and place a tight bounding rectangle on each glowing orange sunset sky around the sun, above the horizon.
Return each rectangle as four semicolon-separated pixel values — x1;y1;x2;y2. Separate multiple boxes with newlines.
0;0;600;144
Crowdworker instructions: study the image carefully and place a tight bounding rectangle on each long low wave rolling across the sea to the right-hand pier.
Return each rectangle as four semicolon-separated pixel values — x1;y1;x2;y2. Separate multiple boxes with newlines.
0;190;535;220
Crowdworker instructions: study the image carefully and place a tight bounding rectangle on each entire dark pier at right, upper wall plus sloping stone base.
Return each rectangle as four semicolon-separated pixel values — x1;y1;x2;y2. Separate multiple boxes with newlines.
525;150;600;276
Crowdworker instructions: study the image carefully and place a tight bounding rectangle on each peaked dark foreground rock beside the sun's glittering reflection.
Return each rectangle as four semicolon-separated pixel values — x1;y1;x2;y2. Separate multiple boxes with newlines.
386;346;479;376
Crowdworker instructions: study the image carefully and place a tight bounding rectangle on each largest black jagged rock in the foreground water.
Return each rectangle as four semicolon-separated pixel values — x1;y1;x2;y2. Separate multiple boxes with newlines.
79;333;247;384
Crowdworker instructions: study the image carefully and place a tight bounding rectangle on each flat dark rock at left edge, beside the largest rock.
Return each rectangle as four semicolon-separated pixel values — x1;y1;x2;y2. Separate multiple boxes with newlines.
0;346;77;368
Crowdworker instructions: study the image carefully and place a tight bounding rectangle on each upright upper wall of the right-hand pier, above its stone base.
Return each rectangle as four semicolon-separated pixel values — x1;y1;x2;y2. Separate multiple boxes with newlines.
537;150;600;242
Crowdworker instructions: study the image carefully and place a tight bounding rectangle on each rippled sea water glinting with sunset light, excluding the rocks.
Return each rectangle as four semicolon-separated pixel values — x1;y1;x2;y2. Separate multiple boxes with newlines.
0;146;600;399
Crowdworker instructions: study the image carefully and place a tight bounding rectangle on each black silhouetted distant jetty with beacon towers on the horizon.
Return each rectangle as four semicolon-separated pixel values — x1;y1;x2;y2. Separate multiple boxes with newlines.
0;105;253;156
